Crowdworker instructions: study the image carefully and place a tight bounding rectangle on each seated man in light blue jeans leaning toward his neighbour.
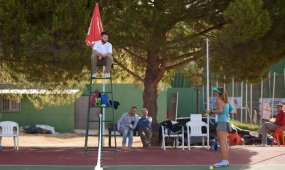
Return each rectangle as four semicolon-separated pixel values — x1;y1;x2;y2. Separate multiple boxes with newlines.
117;106;139;149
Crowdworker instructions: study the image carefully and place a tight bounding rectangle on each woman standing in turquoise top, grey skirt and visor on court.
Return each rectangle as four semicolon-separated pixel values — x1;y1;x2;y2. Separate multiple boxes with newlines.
207;87;233;167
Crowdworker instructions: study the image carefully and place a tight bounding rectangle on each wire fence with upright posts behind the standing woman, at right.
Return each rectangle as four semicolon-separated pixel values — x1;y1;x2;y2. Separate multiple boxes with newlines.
204;73;285;125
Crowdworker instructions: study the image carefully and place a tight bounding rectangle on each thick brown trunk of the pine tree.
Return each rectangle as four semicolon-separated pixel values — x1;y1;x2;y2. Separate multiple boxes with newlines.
143;52;164;123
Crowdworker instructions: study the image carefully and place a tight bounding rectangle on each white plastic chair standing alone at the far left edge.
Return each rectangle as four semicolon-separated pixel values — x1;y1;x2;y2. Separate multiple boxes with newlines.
0;121;19;150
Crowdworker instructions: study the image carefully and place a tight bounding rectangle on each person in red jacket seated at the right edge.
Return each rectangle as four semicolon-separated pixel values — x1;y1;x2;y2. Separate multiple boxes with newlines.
250;103;285;146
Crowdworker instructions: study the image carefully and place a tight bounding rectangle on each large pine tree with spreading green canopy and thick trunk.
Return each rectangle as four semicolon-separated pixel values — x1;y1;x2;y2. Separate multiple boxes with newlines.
0;0;285;122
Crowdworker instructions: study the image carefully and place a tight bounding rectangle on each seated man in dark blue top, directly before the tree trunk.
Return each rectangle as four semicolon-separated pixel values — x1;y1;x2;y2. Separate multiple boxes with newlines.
137;108;152;148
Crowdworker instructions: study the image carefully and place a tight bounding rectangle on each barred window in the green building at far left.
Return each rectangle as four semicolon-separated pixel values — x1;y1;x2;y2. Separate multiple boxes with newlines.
0;98;21;112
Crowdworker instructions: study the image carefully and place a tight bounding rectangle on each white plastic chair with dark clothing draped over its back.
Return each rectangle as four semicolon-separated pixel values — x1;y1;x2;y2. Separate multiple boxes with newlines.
161;121;184;150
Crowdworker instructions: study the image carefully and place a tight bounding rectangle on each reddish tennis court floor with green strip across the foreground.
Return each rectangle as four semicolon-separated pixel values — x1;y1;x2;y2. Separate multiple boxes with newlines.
0;147;285;170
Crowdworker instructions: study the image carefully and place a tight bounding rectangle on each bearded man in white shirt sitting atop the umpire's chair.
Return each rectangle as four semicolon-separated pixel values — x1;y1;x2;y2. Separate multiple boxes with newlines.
91;32;114;78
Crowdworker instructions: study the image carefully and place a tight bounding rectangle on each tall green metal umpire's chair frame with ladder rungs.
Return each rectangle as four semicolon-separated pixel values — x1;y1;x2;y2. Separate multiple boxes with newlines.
84;65;118;157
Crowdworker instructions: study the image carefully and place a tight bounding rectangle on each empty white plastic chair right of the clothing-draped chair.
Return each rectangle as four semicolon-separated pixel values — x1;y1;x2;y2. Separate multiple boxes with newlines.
186;121;209;150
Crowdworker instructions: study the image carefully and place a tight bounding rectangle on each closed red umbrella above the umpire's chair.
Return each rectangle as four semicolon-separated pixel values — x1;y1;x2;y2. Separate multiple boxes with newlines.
85;3;103;46
